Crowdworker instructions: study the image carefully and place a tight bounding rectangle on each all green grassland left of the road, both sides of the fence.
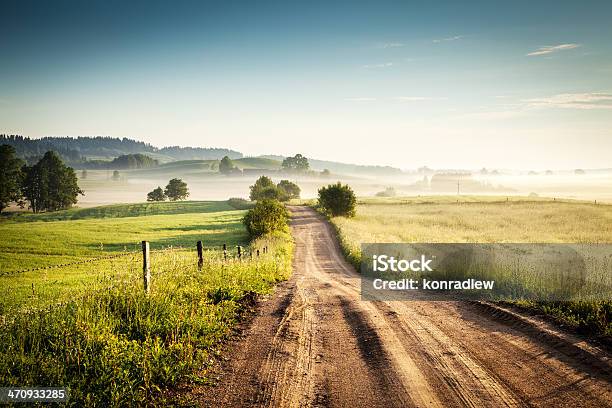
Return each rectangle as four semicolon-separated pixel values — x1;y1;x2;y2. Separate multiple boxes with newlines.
0;202;292;407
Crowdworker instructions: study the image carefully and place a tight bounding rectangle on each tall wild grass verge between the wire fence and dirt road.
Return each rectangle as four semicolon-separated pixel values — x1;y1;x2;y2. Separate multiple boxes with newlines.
0;234;292;406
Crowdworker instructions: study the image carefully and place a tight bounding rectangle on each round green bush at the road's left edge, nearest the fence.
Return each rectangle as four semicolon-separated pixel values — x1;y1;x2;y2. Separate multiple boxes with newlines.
242;200;289;238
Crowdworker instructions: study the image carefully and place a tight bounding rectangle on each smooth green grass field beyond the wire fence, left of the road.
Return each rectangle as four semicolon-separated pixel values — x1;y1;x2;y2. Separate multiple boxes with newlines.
0;201;247;272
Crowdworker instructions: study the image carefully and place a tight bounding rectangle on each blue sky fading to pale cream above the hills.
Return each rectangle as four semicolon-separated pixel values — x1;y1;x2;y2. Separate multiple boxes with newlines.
0;0;612;169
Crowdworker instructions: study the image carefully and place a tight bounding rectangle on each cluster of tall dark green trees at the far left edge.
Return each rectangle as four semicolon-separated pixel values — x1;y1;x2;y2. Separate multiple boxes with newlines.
0;145;83;213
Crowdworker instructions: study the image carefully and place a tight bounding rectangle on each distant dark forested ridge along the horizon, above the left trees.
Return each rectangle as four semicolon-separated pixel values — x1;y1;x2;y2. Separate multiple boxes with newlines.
0;135;243;168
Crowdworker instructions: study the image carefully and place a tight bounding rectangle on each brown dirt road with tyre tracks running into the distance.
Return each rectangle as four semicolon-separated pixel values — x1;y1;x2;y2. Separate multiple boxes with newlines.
194;207;612;407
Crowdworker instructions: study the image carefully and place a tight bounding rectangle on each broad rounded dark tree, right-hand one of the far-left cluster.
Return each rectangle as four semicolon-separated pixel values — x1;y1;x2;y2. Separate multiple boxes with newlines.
23;151;83;212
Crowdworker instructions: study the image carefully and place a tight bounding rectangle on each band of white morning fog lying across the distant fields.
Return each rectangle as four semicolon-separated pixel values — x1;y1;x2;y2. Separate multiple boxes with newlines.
78;169;612;207
